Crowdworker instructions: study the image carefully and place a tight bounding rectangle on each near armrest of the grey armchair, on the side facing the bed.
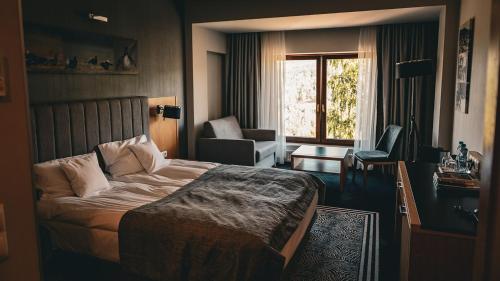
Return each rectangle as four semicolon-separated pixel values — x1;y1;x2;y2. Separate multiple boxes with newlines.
198;138;255;166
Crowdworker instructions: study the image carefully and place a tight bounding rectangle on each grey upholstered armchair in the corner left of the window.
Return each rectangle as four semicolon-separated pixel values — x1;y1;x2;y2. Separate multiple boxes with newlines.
198;116;277;167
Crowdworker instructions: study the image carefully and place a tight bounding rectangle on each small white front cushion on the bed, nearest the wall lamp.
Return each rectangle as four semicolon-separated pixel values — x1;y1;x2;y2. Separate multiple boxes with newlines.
129;140;169;174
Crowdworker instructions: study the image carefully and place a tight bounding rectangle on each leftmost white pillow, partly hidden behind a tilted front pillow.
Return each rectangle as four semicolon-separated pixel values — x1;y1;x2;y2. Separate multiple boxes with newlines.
33;154;91;199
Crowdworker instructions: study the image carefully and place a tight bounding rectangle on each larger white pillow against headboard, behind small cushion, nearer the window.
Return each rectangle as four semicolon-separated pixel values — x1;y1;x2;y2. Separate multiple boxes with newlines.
98;135;148;177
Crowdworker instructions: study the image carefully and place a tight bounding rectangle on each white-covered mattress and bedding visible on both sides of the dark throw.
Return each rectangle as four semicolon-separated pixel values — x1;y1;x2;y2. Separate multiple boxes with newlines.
37;160;318;264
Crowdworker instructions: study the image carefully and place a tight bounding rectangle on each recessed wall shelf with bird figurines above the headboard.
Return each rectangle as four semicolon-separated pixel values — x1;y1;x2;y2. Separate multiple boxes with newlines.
25;23;138;75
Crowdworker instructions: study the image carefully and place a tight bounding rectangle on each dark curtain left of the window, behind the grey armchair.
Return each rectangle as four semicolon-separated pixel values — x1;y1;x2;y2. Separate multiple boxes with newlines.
223;33;260;128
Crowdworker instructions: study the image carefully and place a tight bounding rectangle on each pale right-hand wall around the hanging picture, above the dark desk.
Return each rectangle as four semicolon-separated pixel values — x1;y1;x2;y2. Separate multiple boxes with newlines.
452;0;491;153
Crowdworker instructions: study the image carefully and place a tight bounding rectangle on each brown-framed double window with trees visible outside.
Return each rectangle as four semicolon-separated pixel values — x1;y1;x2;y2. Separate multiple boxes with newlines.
285;54;358;145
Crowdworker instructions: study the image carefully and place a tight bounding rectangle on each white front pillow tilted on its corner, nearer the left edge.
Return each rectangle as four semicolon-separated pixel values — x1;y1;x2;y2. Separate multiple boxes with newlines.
61;153;110;197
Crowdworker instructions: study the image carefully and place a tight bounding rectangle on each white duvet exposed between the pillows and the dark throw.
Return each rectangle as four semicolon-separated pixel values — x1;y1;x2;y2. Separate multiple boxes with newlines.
37;159;217;232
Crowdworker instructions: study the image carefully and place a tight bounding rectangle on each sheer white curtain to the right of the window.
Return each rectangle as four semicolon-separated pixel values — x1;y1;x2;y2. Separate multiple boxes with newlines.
354;27;377;152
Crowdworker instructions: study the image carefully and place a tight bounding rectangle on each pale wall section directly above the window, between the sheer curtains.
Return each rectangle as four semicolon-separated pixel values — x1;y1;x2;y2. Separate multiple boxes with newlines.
285;28;359;54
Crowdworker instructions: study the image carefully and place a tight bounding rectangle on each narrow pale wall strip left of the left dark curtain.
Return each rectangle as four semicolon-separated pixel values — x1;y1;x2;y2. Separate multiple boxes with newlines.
187;25;226;159
